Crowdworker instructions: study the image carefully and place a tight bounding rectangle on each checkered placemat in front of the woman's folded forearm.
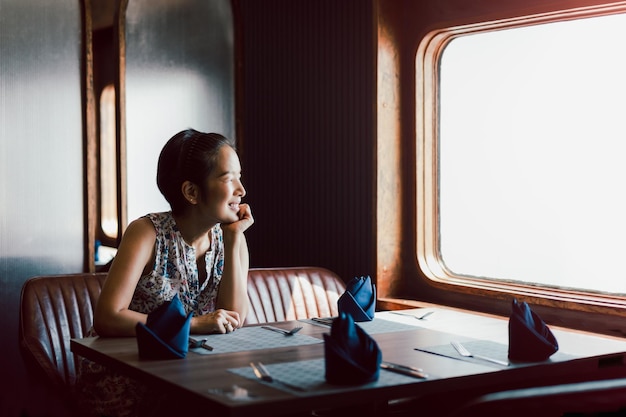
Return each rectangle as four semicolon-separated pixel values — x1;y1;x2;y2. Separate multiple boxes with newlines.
189;326;323;355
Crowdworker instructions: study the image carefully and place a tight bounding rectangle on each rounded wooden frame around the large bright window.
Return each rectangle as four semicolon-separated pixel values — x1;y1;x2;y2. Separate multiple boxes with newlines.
415;4;626;310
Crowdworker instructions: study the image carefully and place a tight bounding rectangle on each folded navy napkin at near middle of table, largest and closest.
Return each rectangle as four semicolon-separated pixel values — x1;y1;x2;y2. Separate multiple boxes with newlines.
324;313;382;385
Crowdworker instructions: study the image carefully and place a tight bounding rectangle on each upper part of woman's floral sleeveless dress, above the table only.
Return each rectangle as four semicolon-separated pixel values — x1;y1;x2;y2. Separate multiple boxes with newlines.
130;211;224;316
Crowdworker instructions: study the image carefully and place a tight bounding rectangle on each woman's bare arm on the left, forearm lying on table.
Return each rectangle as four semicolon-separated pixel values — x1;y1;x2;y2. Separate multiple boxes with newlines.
94;218;156;336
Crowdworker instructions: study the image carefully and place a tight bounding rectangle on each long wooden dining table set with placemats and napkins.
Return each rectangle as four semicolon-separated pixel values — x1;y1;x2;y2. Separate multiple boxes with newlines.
71;307;626;417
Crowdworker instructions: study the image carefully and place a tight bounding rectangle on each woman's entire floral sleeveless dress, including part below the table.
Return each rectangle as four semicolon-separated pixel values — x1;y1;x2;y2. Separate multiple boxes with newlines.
77;212;224;417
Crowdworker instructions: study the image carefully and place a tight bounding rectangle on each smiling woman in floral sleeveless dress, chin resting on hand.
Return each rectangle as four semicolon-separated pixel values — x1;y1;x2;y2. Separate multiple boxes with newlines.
81;129;254;416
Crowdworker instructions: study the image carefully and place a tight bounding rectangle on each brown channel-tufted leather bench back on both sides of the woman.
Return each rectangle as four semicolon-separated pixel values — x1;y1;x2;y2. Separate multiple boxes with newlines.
19;267;345;392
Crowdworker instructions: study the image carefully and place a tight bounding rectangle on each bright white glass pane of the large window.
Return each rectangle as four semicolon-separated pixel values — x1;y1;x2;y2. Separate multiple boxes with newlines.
438;14;626;294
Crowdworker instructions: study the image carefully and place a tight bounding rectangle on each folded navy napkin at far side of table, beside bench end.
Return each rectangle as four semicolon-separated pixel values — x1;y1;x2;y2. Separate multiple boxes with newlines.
337;276;376;322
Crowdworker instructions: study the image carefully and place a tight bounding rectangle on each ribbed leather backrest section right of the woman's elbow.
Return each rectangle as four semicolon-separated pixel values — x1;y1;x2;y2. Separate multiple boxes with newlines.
246;267;346;324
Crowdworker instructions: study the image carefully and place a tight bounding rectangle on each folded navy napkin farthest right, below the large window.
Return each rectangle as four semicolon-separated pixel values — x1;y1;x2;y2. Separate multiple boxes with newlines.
509;299;559;362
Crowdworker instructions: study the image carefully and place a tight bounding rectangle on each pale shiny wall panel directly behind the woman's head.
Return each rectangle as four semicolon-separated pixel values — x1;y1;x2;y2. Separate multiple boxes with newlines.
125;0;235;221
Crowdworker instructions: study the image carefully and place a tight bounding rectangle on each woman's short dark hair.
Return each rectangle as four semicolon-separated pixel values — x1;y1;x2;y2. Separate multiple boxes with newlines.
157;129;235;213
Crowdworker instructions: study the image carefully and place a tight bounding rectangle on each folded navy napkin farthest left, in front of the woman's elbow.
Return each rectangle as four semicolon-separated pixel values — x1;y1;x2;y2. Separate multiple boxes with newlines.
136;294;193;359
